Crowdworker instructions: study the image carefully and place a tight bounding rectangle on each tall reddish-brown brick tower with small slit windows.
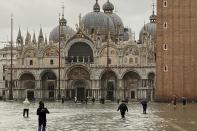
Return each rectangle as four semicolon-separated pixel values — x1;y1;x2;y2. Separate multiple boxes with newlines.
155;0;197;101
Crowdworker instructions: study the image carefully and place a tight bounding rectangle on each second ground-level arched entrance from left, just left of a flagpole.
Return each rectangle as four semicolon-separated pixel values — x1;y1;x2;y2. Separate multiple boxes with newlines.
41;71;57;100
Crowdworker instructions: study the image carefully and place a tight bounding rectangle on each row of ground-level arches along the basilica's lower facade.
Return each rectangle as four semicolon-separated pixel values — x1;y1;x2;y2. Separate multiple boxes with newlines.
15;66;155;100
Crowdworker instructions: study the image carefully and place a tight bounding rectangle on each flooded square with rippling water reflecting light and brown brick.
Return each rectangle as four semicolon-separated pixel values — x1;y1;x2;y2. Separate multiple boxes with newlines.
0;102;197;131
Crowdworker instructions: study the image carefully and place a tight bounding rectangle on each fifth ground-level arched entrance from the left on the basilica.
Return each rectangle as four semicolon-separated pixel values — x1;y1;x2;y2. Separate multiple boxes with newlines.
123;71;140;99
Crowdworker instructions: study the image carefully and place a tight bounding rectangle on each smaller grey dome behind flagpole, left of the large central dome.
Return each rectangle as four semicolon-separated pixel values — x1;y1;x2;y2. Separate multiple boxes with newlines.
49;25;75;43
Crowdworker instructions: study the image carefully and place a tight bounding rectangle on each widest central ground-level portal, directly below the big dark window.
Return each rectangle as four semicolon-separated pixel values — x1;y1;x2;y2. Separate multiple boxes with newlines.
66;67;90;100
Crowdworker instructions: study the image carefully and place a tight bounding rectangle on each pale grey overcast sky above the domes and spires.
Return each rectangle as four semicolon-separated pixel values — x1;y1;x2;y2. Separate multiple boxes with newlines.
0;0;155;47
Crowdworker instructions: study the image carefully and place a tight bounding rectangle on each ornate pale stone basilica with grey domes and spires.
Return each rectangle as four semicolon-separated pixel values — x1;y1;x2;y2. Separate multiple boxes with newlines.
3;1;156;101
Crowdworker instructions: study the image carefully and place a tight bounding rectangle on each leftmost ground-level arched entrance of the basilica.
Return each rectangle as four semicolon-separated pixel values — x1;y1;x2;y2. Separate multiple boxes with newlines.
19;73;35;100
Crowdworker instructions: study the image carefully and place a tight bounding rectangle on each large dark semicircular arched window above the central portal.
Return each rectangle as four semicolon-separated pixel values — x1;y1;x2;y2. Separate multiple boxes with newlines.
67;42;94;63
